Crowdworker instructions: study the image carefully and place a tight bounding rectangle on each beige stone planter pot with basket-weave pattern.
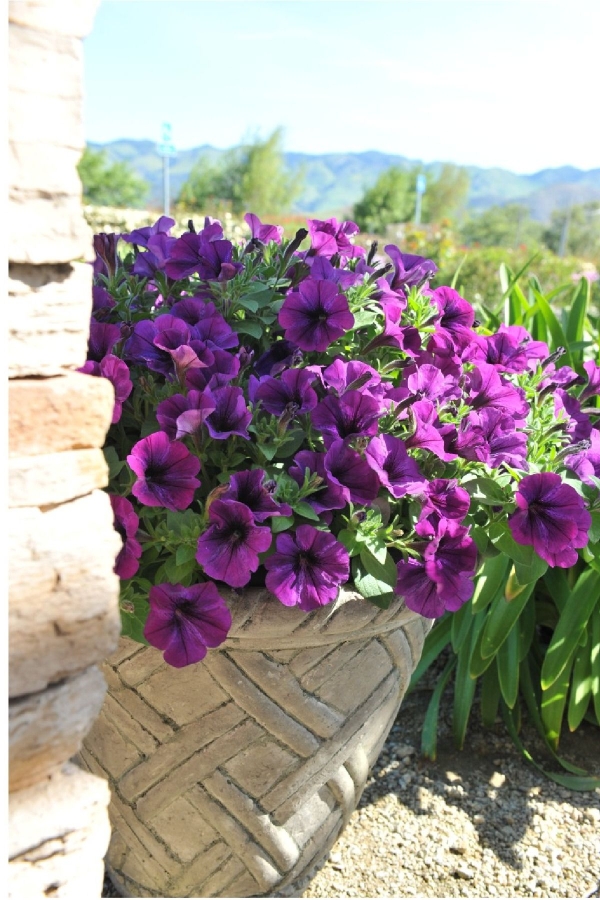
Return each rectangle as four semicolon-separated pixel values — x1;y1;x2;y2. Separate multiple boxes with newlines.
80;589;431;897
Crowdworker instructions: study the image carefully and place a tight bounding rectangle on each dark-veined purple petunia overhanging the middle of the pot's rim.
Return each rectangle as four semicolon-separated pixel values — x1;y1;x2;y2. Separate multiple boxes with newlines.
265;525;350;612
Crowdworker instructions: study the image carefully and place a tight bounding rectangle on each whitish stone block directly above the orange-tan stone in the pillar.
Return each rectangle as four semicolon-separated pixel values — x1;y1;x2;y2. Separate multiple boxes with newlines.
7;260;93;378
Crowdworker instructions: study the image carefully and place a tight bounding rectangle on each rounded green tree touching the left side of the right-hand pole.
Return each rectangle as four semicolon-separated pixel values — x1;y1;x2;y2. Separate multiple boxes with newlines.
352;166;416;234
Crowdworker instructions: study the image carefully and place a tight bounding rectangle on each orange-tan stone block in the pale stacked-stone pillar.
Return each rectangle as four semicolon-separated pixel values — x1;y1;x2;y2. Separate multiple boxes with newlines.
8;372;114;456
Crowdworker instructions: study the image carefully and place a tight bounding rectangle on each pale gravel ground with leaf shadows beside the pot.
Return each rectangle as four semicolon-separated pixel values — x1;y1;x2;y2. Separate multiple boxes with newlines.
103;690;600;898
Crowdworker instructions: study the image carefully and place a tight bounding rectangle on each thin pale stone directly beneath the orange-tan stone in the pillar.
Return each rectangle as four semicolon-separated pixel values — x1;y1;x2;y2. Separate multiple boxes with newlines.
8;449;108;509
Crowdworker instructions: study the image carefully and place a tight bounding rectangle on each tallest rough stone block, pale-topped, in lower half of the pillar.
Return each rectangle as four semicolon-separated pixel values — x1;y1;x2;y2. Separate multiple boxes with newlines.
9;492;121;697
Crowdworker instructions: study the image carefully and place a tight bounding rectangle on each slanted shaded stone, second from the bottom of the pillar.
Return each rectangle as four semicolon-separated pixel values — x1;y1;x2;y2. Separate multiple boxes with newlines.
9;666;106;791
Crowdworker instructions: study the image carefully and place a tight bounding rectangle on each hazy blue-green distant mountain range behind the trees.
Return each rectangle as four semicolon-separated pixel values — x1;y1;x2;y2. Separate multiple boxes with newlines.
90;140;600;222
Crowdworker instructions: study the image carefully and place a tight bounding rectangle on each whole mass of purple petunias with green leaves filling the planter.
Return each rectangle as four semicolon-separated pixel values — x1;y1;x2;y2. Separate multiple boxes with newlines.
83;213;600;666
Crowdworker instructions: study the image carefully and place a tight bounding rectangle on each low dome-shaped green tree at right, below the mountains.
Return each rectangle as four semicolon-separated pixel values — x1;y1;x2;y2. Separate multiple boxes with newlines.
460;203;542;247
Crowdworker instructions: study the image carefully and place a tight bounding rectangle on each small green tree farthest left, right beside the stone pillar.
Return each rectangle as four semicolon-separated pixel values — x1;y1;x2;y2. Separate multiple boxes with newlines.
77;147;150;209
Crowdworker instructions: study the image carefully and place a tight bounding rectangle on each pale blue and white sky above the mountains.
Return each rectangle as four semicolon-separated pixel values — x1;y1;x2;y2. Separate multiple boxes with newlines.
84;0;600;173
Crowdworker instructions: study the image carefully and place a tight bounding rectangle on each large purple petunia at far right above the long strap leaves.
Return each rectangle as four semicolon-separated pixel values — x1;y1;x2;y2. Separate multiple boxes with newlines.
508;472;592;568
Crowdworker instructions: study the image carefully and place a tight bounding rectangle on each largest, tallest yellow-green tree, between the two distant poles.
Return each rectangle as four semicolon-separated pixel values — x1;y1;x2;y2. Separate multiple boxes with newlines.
177;128;303;216
